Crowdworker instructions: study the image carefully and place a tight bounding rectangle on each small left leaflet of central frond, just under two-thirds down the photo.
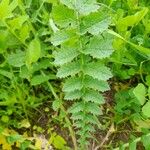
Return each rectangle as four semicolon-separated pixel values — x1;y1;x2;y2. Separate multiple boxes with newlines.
64;90;82;100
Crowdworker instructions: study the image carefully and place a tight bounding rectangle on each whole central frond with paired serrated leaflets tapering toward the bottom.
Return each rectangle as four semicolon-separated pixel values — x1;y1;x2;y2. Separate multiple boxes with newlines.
51;0;113;149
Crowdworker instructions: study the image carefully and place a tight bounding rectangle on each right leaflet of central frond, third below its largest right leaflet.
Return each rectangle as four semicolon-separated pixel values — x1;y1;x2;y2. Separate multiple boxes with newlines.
82;90;105;104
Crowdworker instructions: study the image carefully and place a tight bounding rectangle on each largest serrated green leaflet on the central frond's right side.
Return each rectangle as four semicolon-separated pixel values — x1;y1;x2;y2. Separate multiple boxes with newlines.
84;36;113;59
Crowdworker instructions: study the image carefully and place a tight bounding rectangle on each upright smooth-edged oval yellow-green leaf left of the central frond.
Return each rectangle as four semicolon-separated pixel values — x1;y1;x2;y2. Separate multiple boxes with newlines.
26;38;41;66
